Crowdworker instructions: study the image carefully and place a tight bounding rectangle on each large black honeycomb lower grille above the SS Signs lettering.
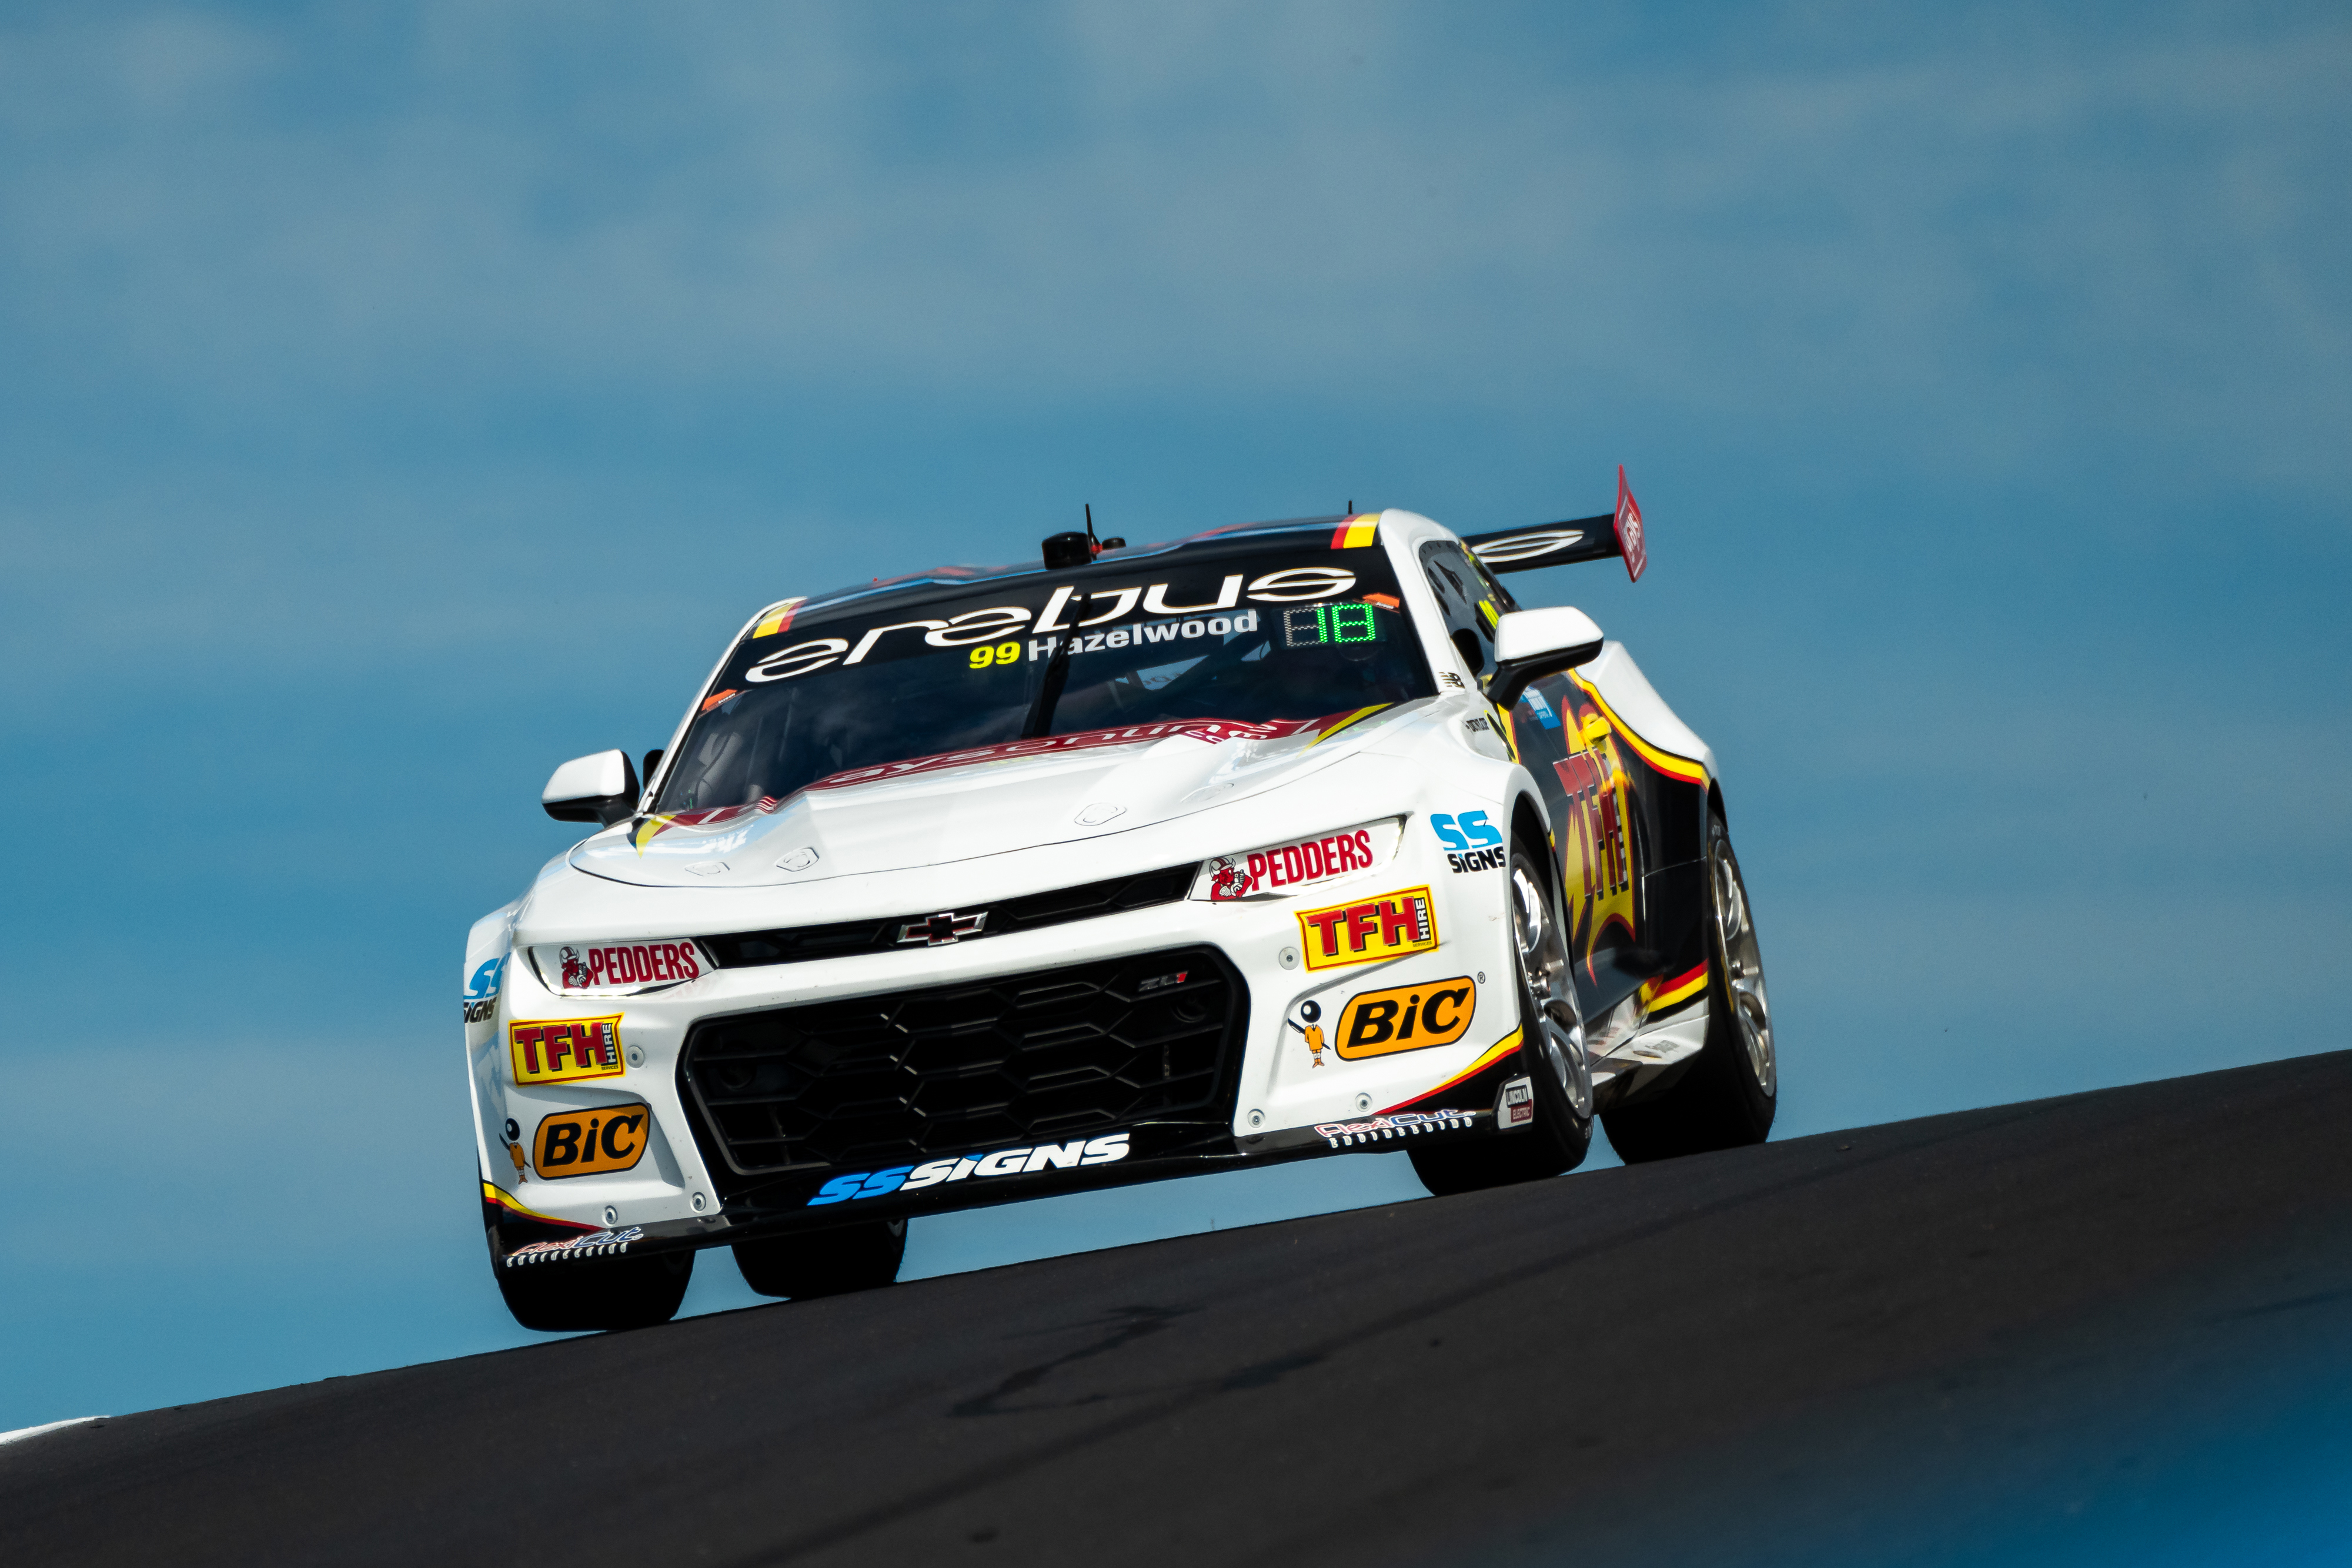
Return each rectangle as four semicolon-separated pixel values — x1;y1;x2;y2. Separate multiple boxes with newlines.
680;947;1249;1175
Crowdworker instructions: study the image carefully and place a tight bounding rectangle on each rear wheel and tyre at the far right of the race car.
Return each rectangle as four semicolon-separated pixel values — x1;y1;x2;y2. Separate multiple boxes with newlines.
1602;813;1780;1166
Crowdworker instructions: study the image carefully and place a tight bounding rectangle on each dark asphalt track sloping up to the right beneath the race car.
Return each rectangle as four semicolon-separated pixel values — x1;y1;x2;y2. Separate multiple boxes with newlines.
0;1053;2352;1568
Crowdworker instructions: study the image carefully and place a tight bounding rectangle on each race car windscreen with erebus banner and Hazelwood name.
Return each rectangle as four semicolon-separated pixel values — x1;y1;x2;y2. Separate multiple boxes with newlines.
656;527;1435;811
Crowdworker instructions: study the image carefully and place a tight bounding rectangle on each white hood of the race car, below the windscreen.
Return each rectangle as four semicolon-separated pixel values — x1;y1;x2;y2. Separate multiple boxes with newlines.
569;698;1430;888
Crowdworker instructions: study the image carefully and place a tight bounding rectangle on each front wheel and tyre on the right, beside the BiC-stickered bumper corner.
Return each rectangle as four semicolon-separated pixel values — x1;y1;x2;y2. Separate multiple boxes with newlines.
1406;841;1592;1196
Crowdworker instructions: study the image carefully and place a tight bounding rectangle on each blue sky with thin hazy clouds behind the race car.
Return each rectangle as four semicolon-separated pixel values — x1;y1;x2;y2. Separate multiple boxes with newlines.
0;0;2352;1427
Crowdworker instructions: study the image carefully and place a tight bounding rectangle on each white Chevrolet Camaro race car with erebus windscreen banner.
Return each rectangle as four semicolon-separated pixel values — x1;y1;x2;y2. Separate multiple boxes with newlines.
463;475;1776;1330
